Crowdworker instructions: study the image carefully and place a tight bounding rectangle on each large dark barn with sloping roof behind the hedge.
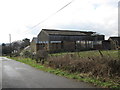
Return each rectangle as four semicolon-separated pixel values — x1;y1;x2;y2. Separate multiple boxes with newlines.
36;29;104;53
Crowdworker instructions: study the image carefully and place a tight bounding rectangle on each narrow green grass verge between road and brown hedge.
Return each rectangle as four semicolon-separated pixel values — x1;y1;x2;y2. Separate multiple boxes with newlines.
8;57;120;89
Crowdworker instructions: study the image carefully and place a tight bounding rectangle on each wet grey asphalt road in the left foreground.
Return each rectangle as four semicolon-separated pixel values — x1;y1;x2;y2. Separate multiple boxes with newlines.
0;57;94;88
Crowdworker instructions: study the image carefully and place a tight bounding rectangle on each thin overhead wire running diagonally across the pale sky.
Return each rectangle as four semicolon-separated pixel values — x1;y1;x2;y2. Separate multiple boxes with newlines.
32;0;74;29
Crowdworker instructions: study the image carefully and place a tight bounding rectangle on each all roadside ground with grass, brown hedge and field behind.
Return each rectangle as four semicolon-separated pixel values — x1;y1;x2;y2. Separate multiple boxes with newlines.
8;50;120;88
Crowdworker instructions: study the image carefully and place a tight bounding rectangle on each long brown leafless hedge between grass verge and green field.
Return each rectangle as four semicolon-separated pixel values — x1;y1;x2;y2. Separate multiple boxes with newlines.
48;53;120;81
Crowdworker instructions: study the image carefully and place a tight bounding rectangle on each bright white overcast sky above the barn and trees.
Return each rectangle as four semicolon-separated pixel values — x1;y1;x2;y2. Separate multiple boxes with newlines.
0;0;119;43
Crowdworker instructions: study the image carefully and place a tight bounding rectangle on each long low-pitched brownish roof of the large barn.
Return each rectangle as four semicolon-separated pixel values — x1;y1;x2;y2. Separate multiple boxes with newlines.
42;29;96;35
